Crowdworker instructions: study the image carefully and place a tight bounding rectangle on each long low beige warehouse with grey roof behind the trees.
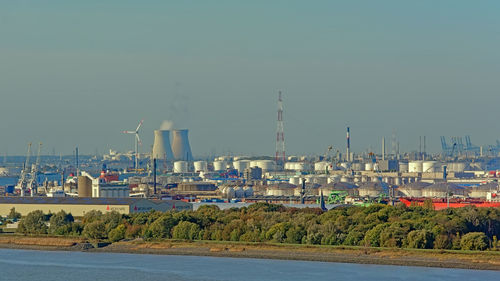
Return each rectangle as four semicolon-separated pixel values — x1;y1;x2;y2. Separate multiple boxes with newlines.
0;197;192;217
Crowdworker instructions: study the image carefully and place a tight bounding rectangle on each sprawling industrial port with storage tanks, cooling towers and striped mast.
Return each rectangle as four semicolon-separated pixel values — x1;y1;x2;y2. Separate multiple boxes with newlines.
0;92;500;215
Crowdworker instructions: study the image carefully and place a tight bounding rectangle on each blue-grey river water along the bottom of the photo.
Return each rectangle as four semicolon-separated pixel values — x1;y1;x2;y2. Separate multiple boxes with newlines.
0;249;500;281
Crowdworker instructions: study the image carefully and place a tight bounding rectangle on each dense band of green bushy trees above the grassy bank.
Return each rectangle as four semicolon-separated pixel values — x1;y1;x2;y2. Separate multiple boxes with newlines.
11;203;500;250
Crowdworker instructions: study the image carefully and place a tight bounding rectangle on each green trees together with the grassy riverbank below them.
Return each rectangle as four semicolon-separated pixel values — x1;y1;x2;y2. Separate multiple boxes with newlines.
0;203;500;270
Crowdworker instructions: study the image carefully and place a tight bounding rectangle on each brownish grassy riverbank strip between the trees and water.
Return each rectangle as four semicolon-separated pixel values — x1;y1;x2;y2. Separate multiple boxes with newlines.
0;235;500;270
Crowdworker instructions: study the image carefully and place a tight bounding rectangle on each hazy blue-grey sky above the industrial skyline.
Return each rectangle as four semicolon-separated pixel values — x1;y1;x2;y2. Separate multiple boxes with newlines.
0;0;500;155
